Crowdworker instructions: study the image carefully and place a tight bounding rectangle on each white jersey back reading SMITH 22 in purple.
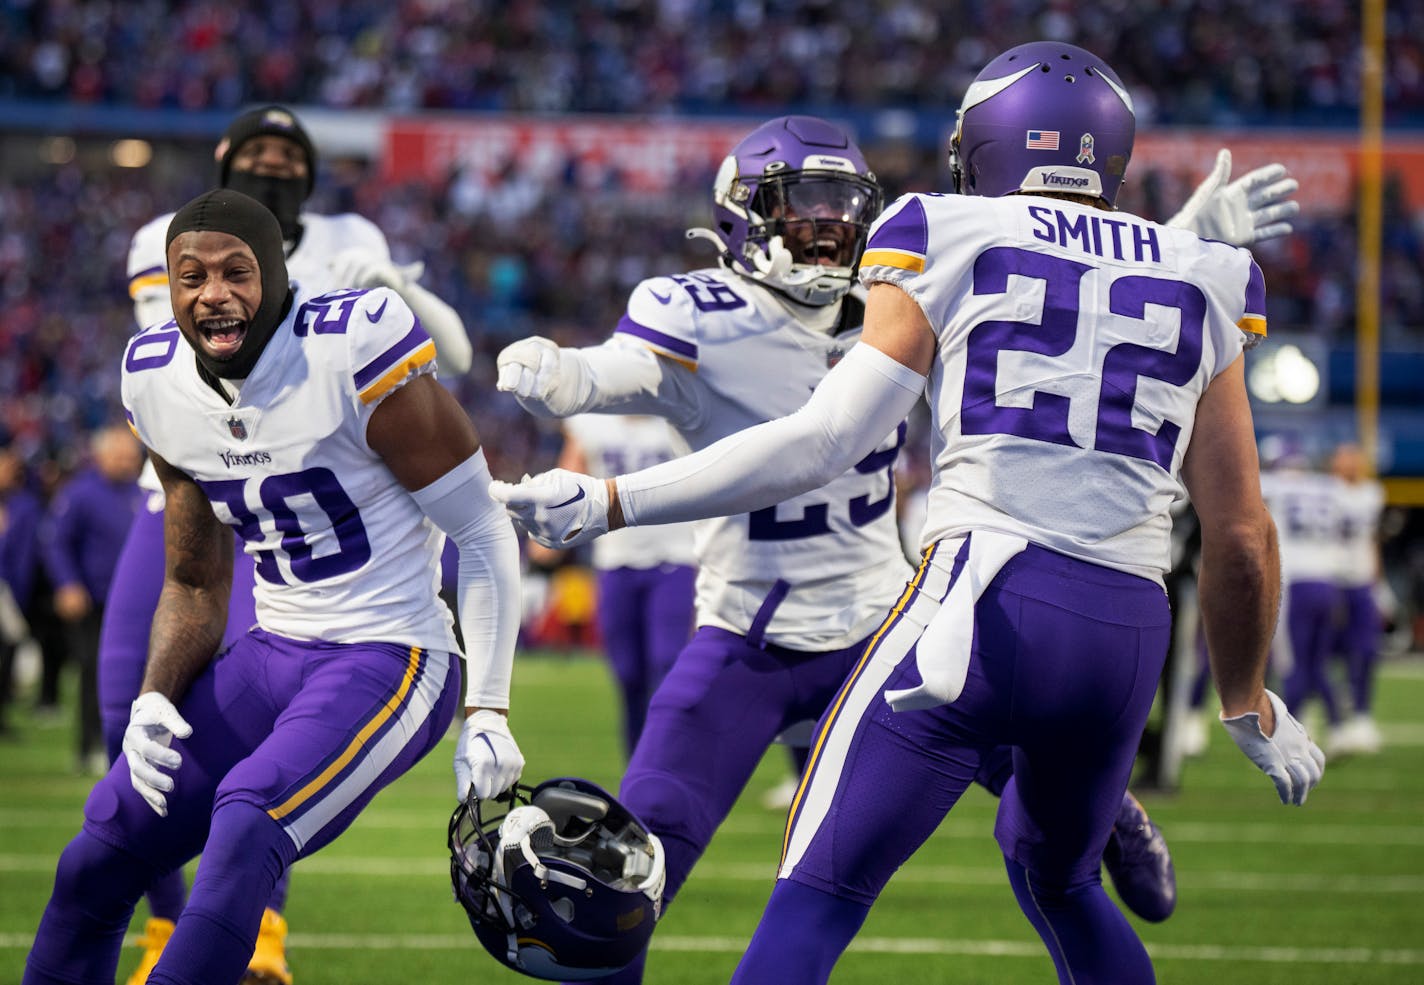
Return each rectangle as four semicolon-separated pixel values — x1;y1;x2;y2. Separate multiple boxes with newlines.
860;195;1265;582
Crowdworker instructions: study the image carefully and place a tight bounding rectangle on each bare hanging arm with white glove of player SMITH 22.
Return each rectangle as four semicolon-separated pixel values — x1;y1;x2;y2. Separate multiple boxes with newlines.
1182;356;1324;804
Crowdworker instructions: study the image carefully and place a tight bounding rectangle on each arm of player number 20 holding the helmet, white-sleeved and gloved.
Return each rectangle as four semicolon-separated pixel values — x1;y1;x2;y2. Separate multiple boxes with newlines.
366;376;524;797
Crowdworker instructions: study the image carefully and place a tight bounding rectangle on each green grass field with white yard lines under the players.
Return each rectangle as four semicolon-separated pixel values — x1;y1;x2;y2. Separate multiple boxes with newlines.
0;655;1424;985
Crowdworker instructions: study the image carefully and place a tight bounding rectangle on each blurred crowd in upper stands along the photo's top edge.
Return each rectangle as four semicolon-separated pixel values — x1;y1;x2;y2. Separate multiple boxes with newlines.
0;0;1424;125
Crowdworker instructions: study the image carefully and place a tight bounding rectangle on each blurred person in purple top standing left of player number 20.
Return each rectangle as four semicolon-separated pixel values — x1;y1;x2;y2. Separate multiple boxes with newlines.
40;426;142;773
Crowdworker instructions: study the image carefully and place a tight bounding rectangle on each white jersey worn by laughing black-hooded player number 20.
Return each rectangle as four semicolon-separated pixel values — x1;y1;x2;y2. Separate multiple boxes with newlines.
122;288;456;652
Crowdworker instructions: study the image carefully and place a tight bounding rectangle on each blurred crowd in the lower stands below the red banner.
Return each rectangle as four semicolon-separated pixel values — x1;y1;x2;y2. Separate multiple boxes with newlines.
0;135;1424;474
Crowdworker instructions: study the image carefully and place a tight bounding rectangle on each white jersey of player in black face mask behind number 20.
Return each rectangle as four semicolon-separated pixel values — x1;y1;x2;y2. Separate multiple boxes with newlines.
128;212;390;501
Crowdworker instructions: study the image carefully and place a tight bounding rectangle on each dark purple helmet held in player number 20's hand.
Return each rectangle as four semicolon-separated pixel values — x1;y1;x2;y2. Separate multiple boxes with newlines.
450;777;666;982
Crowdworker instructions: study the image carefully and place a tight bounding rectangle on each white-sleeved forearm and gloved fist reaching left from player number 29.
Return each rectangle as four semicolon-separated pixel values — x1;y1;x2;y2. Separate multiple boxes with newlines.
497;335;706;430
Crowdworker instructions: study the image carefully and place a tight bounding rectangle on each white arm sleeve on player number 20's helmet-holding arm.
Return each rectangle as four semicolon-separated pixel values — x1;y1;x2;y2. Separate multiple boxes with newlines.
412;451;520;709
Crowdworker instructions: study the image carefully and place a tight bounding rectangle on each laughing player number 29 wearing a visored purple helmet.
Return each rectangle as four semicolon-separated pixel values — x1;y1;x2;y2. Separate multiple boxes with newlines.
498;109;1294;982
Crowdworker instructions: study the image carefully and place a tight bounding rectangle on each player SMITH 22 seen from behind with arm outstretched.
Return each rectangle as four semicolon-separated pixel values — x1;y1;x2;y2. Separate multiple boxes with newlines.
493;43;1323;984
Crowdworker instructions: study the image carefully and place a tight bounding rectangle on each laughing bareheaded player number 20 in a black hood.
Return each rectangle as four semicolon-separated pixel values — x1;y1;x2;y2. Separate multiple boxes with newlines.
24;189;524;985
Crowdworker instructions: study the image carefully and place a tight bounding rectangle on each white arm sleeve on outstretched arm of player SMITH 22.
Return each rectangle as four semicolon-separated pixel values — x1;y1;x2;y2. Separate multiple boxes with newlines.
617;344;924;527
